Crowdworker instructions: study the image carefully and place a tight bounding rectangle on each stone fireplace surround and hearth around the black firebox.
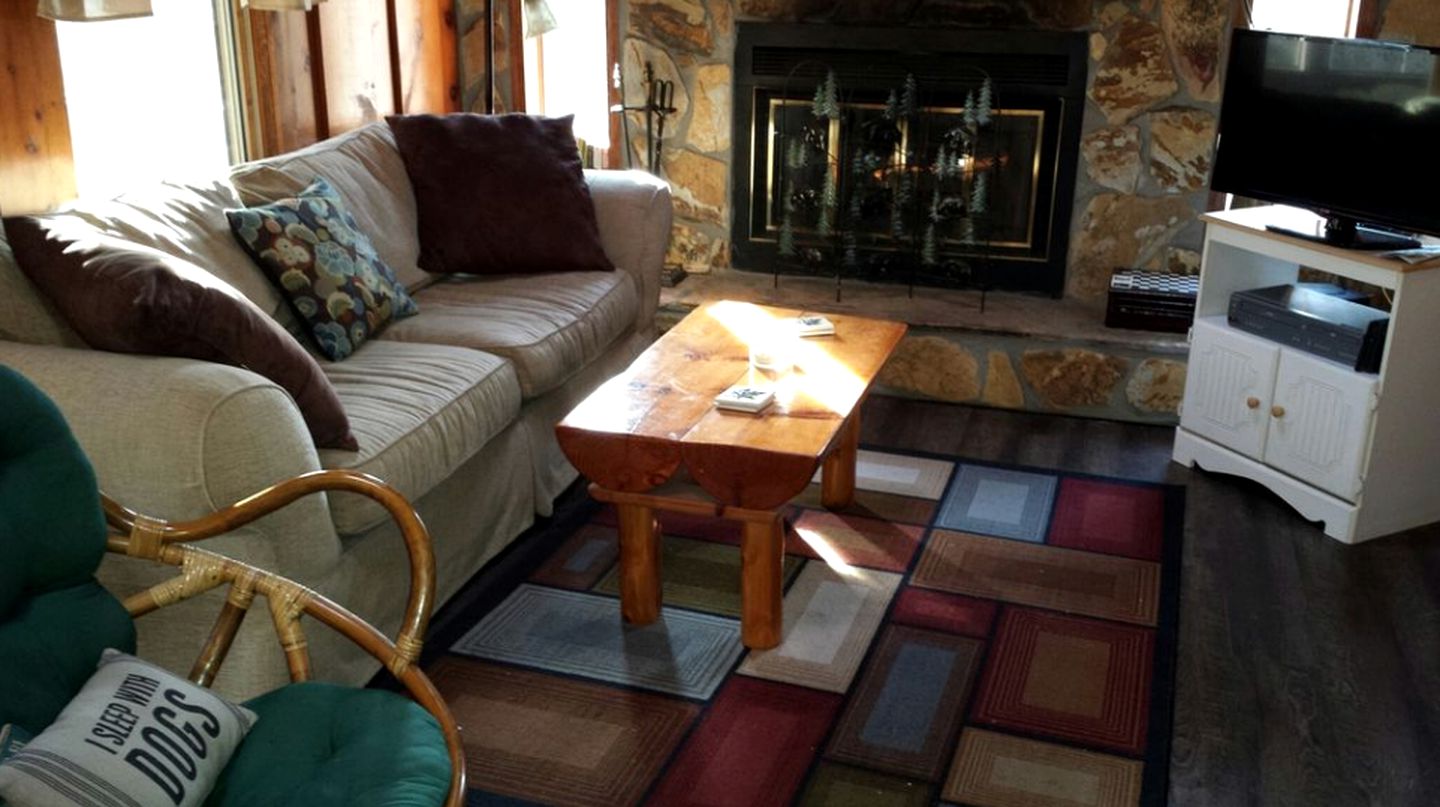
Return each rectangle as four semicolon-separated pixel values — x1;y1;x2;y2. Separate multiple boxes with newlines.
604;0;1226;422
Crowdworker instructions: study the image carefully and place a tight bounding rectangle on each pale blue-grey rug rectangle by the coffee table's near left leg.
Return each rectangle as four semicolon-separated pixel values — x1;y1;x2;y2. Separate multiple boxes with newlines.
451;584;742;700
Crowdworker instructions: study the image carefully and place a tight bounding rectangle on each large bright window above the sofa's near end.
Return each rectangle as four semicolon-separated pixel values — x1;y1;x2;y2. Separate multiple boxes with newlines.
56;0;230;197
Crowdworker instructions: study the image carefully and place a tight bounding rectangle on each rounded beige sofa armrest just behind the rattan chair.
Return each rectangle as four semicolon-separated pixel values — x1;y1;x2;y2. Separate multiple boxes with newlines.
0;342;340;579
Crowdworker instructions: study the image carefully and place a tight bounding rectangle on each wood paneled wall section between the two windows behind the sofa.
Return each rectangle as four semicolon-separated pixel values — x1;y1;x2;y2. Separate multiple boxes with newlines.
241;0;459;157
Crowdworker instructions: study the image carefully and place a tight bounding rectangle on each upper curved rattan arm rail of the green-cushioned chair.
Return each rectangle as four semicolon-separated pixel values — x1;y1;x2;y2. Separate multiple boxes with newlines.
101;470;435;661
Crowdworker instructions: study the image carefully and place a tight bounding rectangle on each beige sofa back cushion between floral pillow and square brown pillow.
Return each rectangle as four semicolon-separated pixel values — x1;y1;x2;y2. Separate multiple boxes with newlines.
230;121;431;291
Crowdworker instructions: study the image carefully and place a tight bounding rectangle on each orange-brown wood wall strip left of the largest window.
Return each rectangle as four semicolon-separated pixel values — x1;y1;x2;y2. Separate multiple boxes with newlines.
0;3;75;215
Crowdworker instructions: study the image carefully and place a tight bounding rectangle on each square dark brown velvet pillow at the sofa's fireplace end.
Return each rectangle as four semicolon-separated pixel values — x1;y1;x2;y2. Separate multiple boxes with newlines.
386;114;615;274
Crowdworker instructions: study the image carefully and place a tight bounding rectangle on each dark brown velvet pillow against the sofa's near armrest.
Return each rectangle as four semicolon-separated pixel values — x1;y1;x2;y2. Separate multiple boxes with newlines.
4;216;359;451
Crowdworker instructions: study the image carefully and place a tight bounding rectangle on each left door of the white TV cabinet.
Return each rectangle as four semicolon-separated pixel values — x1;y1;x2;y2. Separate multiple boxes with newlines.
1179;317;1280;460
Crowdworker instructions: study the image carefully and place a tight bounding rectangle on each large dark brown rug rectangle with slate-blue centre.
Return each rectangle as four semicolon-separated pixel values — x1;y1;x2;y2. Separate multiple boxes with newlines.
825;625;984;781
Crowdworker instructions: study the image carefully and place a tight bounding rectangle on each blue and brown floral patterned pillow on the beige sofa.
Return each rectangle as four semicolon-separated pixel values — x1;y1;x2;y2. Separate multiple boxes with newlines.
225;177;419;360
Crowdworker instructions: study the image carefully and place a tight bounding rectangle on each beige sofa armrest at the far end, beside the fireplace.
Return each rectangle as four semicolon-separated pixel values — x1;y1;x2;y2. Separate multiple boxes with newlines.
585;170;672;333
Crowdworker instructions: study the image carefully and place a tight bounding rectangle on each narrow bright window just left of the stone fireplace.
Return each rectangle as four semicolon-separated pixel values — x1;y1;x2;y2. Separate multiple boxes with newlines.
524;0;611;162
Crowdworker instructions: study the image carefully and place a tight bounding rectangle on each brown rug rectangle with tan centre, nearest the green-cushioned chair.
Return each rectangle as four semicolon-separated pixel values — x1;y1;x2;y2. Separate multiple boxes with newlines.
429;656;700;807
